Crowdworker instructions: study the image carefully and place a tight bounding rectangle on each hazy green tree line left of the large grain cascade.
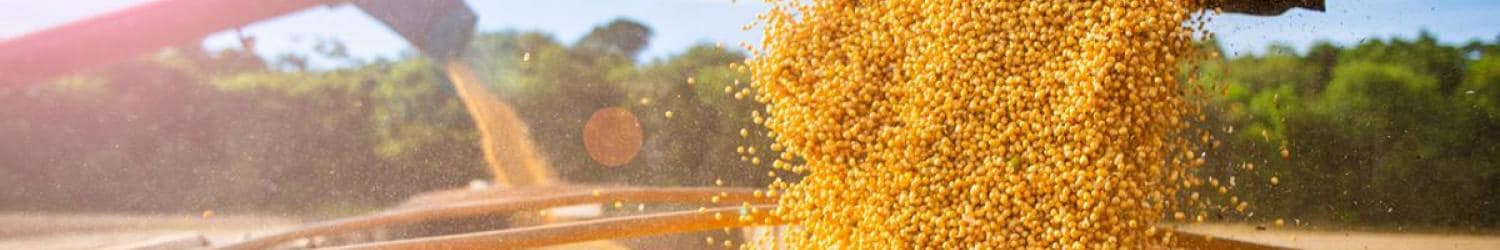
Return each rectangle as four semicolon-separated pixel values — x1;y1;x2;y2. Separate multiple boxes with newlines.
0;19;768;214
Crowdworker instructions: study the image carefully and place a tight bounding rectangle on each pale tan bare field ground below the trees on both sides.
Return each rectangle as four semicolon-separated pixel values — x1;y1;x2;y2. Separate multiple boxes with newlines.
0;213;1500;250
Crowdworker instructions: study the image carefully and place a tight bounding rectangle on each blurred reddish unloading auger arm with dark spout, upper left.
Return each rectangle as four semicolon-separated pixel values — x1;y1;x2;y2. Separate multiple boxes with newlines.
0;0;476;85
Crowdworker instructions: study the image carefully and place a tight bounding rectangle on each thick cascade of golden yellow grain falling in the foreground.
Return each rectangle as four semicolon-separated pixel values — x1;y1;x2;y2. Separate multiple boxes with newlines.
749;0;1203;249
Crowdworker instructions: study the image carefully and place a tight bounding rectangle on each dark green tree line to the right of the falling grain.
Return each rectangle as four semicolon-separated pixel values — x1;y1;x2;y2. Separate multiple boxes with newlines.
1191;31;1500;228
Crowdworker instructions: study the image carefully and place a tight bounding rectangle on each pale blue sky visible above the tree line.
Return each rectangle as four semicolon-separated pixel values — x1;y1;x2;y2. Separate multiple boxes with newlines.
0;0;1500;67
